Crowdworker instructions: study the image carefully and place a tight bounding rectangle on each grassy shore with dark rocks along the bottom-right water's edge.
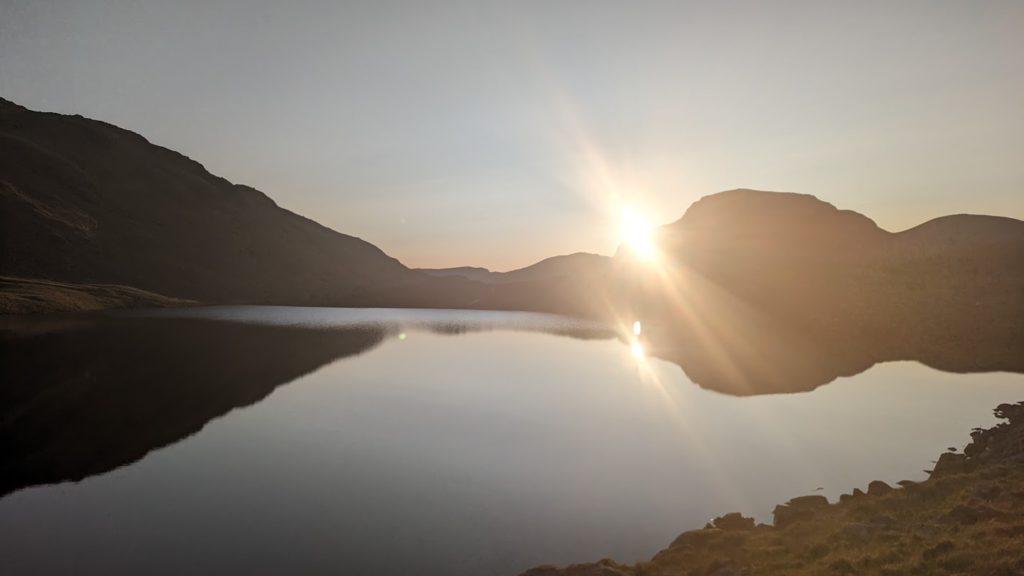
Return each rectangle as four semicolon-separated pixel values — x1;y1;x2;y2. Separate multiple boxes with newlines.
522;402;1024;576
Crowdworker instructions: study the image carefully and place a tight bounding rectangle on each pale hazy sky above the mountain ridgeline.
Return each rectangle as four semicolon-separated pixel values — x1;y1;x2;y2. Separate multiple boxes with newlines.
0;0;1024;270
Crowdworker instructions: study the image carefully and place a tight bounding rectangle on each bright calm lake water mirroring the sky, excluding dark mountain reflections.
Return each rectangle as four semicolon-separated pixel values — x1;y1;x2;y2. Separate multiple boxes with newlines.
0;306;1024;575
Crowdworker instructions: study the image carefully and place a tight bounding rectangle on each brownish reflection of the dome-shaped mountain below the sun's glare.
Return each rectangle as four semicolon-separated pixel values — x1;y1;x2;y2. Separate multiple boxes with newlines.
644;294;1024;396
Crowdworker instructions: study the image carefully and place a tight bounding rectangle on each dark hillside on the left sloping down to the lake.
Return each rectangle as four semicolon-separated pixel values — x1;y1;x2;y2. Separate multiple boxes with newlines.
0;99;481;305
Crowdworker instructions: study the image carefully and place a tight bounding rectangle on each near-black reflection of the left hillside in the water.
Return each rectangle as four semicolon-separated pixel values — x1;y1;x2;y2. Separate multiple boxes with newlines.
0;319;384;494
